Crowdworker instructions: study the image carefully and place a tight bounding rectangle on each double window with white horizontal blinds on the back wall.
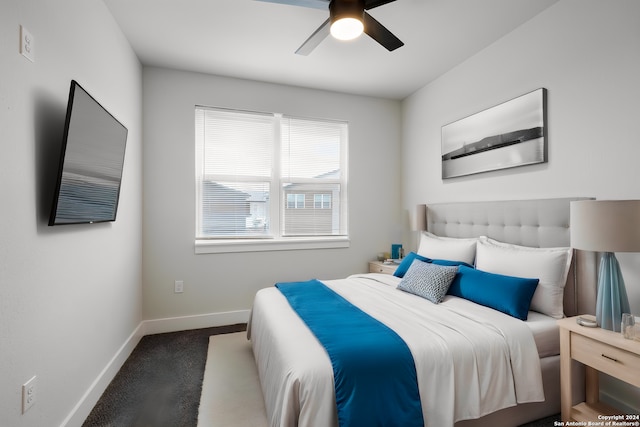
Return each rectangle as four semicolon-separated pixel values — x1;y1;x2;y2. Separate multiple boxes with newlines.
195;106;348;252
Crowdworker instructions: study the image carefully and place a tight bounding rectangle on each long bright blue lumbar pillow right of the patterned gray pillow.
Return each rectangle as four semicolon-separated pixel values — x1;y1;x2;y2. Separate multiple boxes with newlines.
448;265;539;320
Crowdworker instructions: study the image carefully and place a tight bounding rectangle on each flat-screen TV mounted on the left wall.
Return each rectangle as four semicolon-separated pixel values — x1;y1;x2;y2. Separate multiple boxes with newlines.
49;80;127;225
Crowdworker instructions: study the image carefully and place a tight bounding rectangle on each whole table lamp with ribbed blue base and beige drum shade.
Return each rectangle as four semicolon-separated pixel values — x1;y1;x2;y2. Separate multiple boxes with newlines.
570;200;640;332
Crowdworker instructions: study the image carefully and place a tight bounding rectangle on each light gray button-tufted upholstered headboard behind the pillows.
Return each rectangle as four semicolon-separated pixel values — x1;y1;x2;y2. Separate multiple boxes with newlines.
426;198;596;316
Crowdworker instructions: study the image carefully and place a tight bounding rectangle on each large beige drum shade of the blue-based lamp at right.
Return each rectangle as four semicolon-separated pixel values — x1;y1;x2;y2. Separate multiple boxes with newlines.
570;200;640;252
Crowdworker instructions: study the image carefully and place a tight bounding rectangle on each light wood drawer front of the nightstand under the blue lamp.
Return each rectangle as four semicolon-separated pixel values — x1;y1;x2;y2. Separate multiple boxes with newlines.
571;333;640;387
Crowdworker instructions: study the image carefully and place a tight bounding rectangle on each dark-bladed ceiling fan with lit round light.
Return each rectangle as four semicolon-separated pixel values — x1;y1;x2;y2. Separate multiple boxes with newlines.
258;0;404;55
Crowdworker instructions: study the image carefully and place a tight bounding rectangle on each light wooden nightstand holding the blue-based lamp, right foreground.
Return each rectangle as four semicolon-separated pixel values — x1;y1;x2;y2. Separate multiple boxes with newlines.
558;317;640;422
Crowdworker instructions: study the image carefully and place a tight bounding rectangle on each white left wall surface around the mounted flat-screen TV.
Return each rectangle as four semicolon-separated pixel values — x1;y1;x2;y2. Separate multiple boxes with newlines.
0;0;142;427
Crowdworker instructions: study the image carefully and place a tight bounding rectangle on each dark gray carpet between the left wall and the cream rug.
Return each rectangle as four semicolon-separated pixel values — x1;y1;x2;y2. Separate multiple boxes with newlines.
83;324;246;427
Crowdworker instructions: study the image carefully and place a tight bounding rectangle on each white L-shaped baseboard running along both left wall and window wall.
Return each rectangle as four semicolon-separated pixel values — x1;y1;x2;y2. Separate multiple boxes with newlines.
60;310;250;427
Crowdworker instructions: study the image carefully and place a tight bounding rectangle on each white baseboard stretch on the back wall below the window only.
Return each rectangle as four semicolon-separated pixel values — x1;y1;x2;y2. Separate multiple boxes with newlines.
142;310;250;335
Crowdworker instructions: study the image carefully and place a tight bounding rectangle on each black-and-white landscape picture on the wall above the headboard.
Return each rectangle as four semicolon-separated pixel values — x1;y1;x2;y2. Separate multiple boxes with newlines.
442;88;547;179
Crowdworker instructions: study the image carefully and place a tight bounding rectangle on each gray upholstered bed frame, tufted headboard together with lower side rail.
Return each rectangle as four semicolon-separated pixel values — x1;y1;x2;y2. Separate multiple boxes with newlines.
426;198;597;426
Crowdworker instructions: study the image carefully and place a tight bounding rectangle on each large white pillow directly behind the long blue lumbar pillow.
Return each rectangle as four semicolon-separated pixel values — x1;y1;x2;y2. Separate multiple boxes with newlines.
476;236;573;319
